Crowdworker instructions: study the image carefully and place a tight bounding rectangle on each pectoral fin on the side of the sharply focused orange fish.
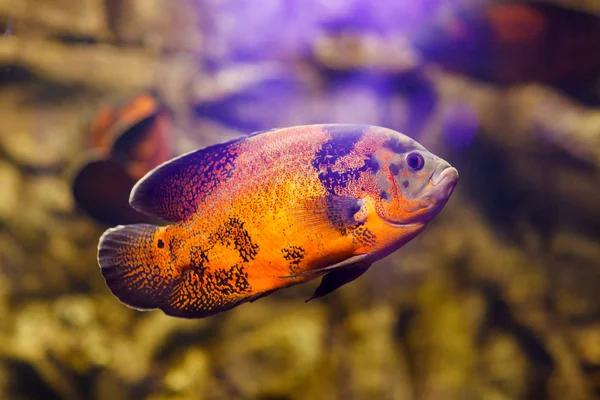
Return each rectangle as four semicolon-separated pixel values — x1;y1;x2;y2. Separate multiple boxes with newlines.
291;195;364;231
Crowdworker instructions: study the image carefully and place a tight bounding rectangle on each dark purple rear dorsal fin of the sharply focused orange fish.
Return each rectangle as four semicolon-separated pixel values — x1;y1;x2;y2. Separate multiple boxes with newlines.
129;136;246;222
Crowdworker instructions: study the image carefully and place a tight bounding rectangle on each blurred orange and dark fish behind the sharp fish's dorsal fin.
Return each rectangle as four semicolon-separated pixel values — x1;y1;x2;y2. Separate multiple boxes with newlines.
72;93;174;225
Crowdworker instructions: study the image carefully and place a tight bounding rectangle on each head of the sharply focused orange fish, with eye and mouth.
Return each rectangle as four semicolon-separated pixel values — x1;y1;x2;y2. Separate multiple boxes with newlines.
372;130;458;226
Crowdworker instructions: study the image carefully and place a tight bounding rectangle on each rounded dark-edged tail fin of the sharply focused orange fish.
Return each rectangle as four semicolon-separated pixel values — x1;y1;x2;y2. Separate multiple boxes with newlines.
98;224;174;310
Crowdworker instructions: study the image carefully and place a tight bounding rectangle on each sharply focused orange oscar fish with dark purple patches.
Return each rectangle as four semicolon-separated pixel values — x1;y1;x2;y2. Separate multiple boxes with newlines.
98;125;458;318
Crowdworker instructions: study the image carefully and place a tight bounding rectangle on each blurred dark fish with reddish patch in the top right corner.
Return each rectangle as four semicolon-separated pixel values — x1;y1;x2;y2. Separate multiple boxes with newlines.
414;1;600;105
